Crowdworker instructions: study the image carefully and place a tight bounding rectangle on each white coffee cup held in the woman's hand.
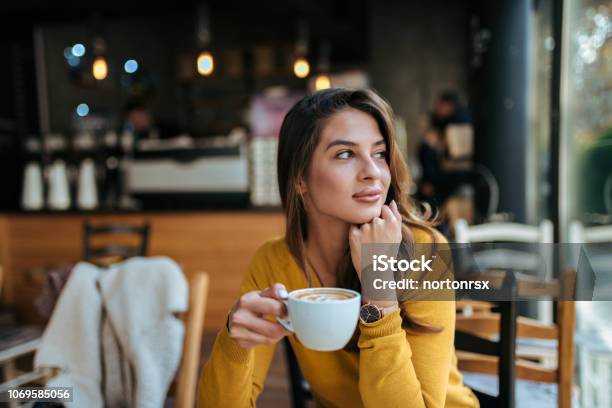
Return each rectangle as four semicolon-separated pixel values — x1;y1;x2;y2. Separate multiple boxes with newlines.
277;288;361;351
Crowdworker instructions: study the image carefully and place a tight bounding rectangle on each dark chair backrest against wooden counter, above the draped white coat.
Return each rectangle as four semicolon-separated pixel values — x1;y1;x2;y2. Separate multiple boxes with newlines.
83;221;150;261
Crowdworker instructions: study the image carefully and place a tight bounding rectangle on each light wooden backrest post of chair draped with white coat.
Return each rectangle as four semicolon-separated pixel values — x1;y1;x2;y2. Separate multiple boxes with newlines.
174;272;209;408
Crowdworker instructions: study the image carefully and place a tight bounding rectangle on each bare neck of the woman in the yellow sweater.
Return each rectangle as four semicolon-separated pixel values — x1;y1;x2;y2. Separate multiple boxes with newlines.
306;210;350;286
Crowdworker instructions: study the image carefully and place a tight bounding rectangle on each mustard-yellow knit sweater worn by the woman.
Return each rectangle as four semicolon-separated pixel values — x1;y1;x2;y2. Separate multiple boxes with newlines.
198;229;479;408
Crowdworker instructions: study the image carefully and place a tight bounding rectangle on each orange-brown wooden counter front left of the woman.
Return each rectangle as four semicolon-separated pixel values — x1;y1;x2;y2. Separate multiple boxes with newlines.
0;211;285;330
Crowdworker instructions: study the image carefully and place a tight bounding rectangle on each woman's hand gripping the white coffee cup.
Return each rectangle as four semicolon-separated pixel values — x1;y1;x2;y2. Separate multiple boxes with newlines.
227;283;289;349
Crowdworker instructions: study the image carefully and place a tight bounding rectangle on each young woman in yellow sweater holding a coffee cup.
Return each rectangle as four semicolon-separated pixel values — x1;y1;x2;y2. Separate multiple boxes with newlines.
199;89;478;407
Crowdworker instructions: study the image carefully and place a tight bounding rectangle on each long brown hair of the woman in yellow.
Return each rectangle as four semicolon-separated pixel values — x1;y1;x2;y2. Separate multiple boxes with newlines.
277;88;440;342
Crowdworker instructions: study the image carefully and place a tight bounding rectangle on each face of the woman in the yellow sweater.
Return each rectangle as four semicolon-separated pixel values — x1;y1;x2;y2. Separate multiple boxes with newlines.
301;108;391;224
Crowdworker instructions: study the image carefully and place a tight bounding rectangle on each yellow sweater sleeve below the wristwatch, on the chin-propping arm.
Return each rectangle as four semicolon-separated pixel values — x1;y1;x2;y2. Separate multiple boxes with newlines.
358;301;455;408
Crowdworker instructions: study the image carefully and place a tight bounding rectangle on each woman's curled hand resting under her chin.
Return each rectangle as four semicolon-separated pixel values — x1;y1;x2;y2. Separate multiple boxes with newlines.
349;200;402;279
